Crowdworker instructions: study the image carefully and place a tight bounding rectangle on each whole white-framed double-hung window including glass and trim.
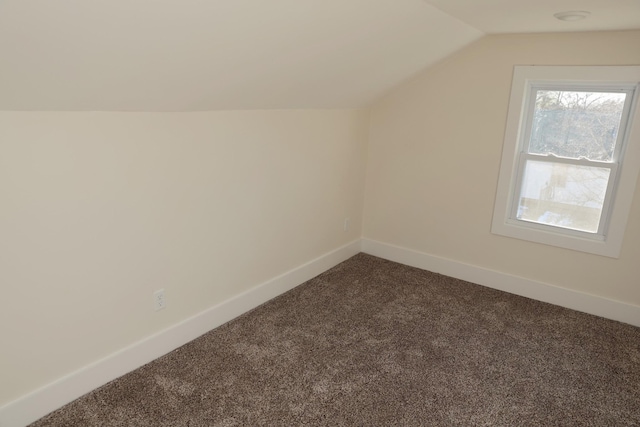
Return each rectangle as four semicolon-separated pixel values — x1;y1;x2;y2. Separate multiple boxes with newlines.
492;66;640;258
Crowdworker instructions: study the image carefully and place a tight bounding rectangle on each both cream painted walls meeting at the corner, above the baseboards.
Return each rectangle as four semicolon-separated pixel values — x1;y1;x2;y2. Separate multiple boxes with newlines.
5;31;640;412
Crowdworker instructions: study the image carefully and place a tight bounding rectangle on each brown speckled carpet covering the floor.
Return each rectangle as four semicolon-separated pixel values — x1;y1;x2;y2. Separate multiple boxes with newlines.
28;254;640;427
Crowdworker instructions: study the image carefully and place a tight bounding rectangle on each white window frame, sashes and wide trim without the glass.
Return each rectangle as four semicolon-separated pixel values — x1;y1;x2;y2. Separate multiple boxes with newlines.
491;66;640;258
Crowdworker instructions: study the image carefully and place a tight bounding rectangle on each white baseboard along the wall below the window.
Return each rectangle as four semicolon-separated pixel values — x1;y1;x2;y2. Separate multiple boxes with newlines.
362;239;640;326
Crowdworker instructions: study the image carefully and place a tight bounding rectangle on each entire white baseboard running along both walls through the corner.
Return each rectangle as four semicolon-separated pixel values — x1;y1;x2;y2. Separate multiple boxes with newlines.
6;239;640;427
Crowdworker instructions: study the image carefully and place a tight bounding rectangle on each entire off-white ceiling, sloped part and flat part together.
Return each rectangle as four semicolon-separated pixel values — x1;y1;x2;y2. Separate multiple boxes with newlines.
0;0;640;111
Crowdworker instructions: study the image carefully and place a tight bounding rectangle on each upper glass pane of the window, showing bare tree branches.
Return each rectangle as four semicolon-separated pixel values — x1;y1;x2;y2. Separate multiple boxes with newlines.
528;89;626;162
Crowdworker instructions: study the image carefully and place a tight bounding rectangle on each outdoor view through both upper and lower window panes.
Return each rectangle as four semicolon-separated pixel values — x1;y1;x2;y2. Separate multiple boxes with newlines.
516;90;626;233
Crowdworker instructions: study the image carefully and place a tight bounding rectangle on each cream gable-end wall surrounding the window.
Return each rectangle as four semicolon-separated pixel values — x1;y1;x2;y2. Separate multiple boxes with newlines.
363;31;640;305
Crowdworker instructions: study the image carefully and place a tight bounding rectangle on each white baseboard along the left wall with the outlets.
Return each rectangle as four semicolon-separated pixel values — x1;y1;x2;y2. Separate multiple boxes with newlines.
0;239;360;427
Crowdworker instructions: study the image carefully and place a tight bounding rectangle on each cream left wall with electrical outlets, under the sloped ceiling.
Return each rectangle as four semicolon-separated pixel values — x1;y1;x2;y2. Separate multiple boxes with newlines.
0;110;368;406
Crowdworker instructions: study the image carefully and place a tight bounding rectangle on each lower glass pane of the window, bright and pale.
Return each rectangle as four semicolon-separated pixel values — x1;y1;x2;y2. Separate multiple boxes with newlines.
516;160;611;233
